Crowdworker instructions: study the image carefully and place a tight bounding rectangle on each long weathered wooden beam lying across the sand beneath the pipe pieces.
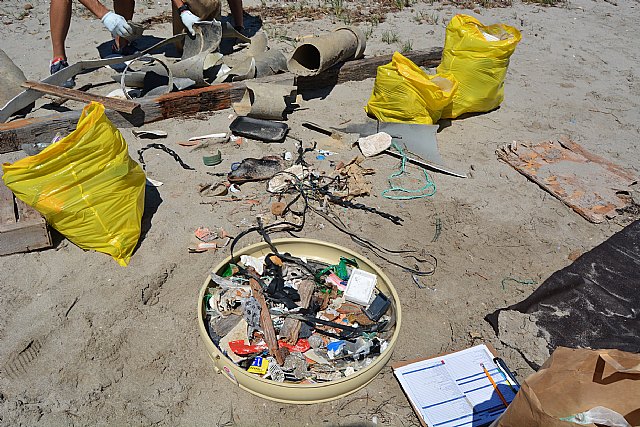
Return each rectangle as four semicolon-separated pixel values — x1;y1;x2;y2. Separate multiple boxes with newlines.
0;49;442;153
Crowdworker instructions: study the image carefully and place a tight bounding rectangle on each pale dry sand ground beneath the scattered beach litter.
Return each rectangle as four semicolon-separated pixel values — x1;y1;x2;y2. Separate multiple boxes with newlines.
0;0;640;426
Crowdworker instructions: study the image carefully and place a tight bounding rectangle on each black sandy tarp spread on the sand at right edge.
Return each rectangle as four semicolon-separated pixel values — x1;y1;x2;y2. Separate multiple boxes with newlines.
485;221;640;368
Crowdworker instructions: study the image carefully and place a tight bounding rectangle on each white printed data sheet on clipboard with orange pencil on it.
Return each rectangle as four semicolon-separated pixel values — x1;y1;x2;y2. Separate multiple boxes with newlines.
394;345;515;427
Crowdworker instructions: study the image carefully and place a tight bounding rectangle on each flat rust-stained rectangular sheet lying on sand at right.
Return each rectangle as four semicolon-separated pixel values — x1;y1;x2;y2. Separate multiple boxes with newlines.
496;140;637;223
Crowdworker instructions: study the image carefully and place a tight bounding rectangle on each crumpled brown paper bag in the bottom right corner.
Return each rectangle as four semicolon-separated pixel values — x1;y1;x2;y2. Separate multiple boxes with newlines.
497;347;640;427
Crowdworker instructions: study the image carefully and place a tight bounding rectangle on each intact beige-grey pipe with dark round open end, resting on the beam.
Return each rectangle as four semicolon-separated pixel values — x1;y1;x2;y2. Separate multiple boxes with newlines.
287;27;367;76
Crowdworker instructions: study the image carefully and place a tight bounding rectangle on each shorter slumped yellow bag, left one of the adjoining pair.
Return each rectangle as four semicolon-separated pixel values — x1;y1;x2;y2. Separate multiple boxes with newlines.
365;52;458;125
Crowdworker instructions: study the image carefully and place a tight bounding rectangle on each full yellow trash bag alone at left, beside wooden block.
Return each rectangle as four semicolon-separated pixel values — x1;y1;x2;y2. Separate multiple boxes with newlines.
2;102;145;266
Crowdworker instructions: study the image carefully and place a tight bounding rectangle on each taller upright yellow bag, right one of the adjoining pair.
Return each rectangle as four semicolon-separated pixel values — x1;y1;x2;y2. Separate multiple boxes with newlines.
437;15;522;119
